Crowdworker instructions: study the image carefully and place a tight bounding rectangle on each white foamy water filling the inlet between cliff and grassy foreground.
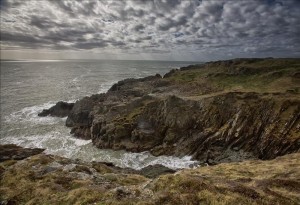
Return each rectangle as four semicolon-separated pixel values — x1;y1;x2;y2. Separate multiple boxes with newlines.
1;131;196;170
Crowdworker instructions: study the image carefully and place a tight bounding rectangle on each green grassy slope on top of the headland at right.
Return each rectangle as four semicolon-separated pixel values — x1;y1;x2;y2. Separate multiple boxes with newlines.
169;59;300;93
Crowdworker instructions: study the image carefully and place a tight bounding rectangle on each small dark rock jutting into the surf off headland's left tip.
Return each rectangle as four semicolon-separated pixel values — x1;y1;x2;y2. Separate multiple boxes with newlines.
38;101;74;117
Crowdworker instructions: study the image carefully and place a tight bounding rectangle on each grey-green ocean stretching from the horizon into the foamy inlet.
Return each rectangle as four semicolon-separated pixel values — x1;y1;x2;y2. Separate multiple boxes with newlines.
0;60;202;169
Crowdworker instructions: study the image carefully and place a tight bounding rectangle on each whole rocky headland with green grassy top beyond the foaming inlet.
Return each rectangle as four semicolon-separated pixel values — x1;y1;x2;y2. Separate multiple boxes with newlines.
59;59;300;163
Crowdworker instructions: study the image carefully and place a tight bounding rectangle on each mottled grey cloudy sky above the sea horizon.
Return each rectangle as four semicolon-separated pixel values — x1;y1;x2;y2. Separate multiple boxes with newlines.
0;0;300;61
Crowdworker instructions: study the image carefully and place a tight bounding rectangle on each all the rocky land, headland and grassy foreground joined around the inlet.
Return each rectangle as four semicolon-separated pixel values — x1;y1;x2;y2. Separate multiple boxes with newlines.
0;58;300;204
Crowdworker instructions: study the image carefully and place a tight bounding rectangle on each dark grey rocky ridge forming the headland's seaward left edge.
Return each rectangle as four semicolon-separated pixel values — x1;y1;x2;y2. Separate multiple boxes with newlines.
66;74;161;139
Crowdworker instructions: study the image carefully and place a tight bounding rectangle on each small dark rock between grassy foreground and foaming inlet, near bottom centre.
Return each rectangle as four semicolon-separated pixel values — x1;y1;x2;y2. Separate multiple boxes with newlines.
138;164;176;178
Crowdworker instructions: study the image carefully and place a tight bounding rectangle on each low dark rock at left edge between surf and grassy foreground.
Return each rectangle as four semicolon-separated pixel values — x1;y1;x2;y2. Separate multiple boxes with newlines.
0;144;44;162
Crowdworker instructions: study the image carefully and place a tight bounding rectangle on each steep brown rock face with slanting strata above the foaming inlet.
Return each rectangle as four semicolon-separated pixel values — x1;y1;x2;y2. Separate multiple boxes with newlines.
91;92;300;164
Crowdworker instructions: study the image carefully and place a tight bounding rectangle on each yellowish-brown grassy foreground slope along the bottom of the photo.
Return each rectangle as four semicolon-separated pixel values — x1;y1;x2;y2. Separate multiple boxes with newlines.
0;147;300;205
